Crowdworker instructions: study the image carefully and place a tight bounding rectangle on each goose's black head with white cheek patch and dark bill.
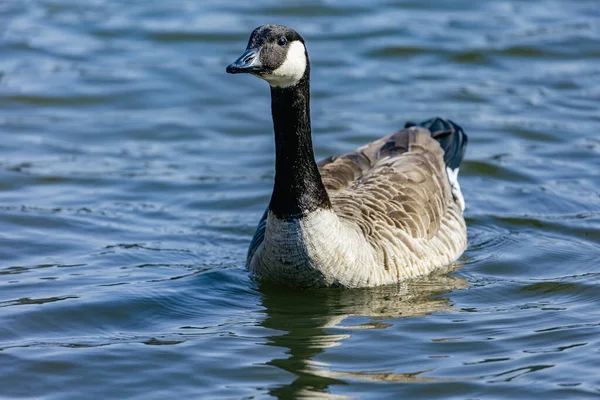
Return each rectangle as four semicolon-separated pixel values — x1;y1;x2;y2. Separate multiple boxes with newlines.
227;25;309;88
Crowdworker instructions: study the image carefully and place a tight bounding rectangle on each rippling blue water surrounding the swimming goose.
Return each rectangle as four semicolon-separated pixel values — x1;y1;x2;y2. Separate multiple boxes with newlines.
0;0;600;399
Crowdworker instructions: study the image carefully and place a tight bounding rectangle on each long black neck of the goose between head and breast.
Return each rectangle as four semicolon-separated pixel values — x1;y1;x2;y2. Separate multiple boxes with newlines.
269;75;331;219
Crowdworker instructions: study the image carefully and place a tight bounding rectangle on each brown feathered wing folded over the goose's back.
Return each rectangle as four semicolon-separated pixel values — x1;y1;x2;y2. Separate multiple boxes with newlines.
319;127;453;238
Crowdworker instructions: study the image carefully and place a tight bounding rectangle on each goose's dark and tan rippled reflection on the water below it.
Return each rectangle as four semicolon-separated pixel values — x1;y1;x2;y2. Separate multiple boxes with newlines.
260;268;467;398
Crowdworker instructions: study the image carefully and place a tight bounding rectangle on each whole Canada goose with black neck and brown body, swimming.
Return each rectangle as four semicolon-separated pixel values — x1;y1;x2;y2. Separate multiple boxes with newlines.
227;25;467;288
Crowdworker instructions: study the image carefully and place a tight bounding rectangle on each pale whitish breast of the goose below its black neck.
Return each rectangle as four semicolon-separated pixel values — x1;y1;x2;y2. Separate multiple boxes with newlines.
249;210;376;287
